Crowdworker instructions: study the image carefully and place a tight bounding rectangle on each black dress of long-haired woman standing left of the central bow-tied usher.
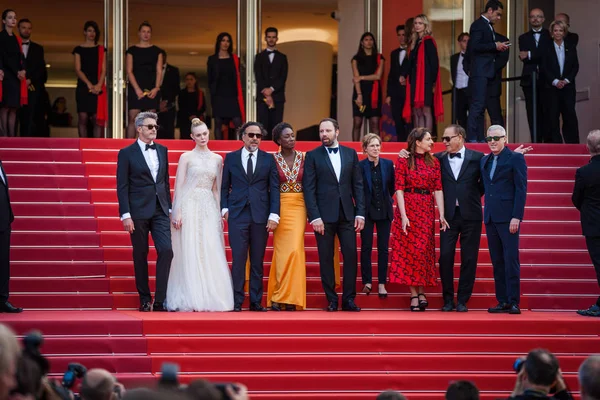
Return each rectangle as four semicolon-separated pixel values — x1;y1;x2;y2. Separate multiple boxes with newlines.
208;54;242;118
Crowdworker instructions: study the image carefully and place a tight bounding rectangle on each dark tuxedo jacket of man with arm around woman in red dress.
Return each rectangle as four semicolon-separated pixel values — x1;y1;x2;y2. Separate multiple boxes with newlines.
435;148;484;221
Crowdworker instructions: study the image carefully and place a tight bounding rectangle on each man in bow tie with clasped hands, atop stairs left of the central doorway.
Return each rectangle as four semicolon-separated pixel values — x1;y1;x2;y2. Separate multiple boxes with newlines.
254;27;288;136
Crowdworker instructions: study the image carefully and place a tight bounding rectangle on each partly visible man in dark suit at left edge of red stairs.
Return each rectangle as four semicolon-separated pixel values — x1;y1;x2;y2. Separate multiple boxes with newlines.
0;161;23;313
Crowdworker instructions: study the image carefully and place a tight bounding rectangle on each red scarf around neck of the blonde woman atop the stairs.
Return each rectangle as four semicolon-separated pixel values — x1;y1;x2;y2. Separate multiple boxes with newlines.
402;35;444;122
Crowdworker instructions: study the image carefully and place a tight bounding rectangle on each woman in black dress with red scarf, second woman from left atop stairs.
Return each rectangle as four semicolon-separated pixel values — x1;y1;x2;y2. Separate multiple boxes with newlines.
73;21;108;138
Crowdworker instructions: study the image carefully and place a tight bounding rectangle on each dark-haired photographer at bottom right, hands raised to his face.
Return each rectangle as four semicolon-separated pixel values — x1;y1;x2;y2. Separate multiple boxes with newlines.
509;349;573;400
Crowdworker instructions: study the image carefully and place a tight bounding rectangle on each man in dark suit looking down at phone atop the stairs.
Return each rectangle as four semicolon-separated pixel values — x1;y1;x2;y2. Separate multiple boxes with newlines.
467;0;509;142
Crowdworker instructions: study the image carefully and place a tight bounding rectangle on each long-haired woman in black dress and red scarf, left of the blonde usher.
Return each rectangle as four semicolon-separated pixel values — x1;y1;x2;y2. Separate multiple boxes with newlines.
352;32;385;142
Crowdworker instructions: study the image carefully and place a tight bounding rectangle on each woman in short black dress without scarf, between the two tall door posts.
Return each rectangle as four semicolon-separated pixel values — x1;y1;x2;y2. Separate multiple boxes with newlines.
127;22;163;138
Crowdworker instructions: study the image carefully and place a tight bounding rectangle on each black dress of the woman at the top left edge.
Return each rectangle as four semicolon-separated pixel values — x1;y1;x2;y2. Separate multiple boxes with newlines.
0;30;25;108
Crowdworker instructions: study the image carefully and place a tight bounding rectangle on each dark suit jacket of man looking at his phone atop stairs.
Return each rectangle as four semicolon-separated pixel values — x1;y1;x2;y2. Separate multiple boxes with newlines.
465;17;499;78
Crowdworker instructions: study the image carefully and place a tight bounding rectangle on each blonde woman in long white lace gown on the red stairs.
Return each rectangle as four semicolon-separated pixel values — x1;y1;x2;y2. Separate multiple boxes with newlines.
167;118;233;311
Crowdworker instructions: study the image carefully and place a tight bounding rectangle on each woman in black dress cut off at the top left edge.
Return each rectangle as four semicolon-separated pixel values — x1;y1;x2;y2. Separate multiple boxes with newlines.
0;9;27;136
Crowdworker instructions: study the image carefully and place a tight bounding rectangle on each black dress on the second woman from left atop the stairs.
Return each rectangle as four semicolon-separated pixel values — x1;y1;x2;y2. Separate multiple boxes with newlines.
73;46;106;114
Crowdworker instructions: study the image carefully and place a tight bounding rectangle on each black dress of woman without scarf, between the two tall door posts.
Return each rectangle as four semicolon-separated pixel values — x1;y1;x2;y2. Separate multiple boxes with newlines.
127;46;161;110
